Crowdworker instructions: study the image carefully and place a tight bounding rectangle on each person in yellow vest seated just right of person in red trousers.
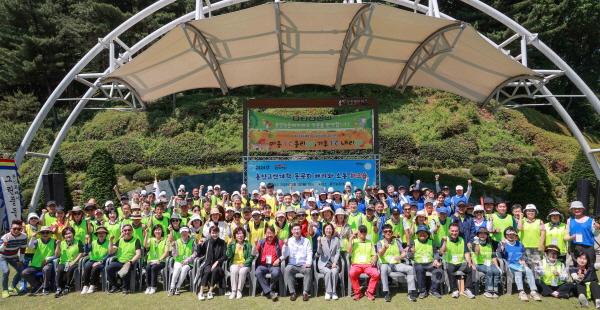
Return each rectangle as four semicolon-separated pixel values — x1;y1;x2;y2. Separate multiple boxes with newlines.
377;224;417;302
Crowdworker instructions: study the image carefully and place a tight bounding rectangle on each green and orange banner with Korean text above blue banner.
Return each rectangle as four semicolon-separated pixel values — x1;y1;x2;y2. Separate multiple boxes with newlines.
248;110;373;151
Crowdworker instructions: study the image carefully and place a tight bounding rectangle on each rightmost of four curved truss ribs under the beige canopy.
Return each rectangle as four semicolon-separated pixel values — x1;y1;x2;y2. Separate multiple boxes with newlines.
394;22;466;92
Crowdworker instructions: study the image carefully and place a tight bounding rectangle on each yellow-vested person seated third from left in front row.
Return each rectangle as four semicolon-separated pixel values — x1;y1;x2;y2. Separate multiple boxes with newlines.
54;227;83;298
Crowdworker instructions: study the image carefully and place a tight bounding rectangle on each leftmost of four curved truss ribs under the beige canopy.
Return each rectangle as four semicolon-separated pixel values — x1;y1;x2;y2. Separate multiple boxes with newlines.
182;23;229;95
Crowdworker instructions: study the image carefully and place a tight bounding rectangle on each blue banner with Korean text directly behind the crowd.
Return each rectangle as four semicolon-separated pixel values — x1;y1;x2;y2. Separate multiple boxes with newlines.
246;159;377;192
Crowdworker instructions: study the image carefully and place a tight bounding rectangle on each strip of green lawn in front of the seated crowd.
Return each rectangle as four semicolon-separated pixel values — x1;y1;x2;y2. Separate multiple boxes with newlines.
0;292;579;310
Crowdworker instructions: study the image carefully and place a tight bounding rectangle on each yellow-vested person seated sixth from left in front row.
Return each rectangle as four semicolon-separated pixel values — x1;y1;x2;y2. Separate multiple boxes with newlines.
144;225;169;295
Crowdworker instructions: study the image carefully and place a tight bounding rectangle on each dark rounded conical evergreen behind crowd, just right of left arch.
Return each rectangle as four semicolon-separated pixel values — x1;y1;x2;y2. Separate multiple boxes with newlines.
83;149;117;203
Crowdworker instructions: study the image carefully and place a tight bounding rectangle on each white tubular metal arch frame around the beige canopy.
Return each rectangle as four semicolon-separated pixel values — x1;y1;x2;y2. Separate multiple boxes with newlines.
15;0;600;206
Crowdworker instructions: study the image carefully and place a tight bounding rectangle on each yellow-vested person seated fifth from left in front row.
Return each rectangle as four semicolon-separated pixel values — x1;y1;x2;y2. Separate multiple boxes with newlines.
106;224;142;294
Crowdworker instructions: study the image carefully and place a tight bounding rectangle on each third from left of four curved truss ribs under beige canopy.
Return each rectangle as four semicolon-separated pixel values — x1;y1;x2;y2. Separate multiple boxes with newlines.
335;4;374;91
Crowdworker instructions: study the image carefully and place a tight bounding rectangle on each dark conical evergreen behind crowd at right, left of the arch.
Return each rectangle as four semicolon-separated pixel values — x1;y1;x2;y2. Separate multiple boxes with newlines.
508;158;558;218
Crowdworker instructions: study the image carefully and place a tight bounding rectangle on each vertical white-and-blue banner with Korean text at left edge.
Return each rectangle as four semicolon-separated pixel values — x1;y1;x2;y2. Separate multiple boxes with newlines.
0;159;22;231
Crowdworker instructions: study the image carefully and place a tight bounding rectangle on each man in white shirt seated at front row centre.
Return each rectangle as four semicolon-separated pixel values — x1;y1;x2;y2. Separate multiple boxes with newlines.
283;223;312;301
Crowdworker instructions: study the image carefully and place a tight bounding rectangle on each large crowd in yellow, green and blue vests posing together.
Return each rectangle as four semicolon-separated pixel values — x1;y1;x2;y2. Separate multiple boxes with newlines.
0;176;600;308
